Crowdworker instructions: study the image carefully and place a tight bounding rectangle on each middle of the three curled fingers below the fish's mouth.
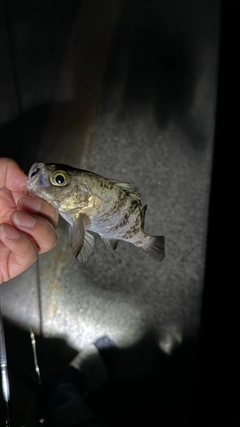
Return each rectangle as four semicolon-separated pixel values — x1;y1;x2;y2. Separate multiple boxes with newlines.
11;211;57;253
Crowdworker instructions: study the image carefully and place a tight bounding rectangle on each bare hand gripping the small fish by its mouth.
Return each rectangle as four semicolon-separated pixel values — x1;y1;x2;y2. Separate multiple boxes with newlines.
0;158;58;285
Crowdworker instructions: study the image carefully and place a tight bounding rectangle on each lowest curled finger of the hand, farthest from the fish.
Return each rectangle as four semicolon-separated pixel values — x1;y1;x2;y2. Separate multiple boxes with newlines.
0;224;38;281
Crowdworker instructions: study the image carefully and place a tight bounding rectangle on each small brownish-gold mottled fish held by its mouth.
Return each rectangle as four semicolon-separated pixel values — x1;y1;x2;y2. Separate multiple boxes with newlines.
27;162;165;264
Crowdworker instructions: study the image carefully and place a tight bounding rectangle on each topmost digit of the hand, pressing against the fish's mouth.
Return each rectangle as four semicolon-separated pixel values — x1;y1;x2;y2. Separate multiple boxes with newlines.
0;157;27;191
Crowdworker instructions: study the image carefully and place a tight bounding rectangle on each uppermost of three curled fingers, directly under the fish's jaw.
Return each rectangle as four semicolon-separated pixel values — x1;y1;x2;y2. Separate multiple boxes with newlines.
17;196;59;228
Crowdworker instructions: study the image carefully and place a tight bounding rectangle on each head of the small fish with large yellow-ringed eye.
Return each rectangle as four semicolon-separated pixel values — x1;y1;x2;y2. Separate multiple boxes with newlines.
27;162;81;210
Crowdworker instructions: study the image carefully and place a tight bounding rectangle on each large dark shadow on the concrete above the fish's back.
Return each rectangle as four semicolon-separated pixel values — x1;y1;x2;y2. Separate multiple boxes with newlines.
101;1;217;149
